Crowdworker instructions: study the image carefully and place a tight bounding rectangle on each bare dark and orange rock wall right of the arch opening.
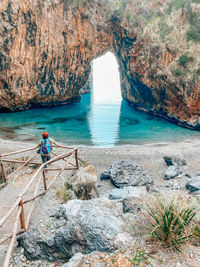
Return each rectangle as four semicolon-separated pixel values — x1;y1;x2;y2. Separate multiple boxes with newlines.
111;18;200;129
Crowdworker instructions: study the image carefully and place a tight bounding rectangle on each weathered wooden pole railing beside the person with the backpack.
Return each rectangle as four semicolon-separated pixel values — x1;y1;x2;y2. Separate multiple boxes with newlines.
0;145;79;267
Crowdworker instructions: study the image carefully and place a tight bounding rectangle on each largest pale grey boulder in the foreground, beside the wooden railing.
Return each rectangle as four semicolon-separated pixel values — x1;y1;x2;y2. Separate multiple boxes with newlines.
18;198;133;262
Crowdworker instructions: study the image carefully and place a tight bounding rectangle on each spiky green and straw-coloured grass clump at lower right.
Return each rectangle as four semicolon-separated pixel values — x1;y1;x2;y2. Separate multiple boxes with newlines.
146;199;197;251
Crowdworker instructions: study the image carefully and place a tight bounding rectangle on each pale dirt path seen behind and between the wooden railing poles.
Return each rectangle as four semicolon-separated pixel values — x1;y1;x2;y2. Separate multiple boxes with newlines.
0;150;72;266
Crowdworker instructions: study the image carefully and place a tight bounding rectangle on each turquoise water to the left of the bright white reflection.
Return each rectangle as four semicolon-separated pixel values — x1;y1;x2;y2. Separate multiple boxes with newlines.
0;94;92;145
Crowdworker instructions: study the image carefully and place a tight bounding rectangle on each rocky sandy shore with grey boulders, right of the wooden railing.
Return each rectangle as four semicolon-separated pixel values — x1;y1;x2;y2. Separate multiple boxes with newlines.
0;139;200;267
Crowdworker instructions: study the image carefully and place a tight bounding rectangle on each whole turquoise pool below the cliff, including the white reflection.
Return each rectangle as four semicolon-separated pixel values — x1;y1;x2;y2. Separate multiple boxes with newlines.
0;94;199;147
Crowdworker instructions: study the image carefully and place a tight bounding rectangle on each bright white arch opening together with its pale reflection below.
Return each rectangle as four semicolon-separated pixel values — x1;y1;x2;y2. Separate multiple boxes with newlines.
89;52;122;146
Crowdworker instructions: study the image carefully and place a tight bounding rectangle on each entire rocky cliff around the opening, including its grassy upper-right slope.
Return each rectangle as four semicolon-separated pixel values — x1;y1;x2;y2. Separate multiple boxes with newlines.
0;0;200;128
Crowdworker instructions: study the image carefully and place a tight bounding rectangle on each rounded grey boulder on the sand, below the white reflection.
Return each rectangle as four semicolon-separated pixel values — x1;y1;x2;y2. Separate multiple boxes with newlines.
100;160;153;188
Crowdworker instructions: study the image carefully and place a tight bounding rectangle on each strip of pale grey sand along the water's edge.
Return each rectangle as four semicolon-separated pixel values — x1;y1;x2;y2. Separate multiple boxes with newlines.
0;139;200;182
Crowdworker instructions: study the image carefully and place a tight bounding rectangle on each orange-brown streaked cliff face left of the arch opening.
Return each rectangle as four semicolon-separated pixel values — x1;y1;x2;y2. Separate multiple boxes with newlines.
0;0;112;111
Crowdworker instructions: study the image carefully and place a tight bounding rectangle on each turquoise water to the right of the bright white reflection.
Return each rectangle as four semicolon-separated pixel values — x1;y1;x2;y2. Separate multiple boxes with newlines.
115;100;199;145
